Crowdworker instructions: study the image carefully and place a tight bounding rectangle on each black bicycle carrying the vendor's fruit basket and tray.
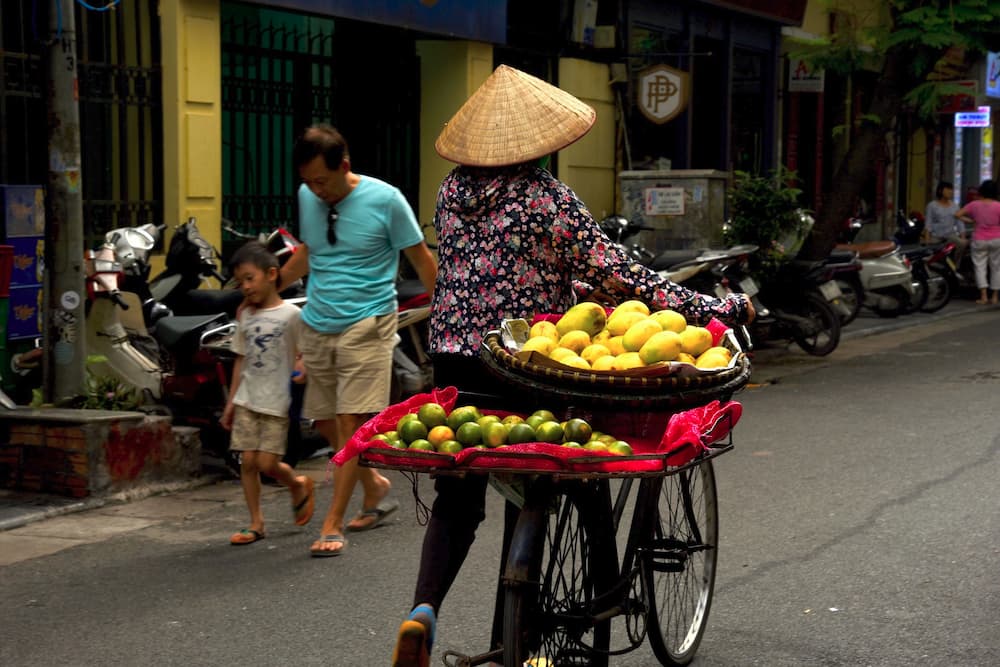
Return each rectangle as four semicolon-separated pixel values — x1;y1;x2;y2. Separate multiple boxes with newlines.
360;328;750;667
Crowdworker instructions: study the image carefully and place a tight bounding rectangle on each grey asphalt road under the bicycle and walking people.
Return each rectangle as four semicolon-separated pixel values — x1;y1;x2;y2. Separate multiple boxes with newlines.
0;309;1000;667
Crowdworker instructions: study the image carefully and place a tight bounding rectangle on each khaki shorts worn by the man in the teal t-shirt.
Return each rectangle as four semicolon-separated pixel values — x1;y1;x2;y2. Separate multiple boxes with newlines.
299;312;396;419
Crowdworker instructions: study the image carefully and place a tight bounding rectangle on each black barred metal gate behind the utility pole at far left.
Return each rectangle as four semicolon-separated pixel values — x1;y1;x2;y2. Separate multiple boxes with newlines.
0;0;163;245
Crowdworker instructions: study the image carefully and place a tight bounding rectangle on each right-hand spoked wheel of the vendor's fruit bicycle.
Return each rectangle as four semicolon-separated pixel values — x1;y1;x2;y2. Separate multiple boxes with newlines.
638;461;719;665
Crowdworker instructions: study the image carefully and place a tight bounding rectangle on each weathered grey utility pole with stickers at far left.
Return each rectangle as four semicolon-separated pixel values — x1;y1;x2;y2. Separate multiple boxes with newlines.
43;0;86;402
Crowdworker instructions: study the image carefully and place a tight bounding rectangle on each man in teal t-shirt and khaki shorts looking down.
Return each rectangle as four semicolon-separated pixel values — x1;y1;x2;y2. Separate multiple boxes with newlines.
280;125;437;556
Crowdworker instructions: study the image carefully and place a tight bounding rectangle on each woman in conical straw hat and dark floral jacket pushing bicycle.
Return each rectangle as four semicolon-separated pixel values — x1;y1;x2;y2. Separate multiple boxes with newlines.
392;65;753;667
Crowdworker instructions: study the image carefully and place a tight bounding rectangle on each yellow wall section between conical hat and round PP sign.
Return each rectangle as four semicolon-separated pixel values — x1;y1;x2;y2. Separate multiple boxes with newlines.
556;58;616;219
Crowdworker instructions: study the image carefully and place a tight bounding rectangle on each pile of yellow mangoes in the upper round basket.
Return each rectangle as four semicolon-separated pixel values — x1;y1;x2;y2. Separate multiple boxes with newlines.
521;300;732;371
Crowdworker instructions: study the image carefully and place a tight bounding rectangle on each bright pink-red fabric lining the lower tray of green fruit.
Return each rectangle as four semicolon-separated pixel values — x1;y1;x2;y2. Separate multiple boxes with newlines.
333;387;743;474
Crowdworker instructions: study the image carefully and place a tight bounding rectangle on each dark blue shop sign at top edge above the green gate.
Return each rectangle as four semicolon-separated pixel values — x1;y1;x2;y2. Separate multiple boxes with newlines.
257;0;507;44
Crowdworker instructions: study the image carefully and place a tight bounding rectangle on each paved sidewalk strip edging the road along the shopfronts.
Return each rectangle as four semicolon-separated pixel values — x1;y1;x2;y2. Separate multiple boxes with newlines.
0;300;984;544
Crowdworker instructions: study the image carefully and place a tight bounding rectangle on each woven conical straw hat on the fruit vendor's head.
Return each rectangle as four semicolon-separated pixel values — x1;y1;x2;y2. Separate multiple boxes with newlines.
434;65;597;167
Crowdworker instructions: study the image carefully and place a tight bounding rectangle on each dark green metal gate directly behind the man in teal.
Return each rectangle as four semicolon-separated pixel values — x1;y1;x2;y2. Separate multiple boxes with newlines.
222;2;420;250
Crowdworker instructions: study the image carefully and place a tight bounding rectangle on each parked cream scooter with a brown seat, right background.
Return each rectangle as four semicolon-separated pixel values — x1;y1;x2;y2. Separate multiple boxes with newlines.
836;218;917;317
